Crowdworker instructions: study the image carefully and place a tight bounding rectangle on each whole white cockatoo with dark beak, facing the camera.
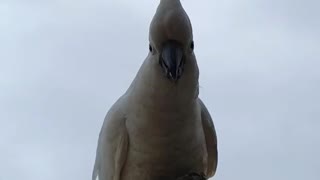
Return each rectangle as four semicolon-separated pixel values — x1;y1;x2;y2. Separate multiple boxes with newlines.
92;0;218;180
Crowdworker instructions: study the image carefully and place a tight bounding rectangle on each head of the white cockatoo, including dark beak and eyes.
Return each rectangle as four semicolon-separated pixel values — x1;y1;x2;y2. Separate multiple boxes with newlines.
149;0;194;82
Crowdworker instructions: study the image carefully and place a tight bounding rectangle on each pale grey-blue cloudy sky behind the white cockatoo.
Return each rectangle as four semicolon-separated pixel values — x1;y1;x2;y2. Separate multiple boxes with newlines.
0;0;320;180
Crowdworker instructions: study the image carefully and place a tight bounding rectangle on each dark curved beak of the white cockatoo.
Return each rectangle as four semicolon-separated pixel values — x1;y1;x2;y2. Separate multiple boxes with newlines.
160;41;184;81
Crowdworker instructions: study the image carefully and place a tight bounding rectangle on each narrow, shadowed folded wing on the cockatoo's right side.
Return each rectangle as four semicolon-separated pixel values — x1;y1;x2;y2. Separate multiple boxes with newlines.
199;98;218;177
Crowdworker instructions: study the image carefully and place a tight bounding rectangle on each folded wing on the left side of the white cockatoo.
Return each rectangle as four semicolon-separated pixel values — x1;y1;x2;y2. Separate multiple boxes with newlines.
92;97;129;180
